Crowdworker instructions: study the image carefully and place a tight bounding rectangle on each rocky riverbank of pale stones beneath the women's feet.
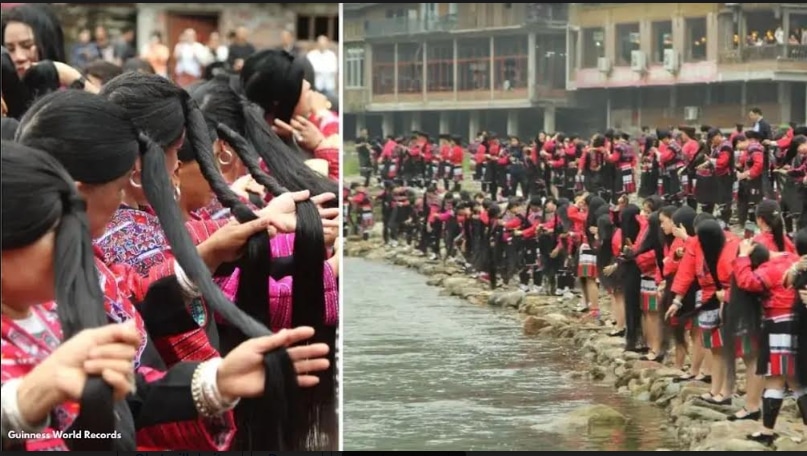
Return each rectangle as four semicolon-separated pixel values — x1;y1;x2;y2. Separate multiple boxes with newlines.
345;238;807;451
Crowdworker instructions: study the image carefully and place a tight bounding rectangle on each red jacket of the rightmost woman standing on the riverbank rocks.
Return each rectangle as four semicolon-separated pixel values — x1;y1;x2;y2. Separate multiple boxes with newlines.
734;253;799;318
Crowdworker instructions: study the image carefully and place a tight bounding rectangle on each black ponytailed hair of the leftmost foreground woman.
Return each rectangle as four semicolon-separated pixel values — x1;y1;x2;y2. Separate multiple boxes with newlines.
0;141;121;451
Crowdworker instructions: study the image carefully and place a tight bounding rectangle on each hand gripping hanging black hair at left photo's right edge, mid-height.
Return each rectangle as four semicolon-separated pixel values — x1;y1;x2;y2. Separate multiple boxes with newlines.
257;190;341;233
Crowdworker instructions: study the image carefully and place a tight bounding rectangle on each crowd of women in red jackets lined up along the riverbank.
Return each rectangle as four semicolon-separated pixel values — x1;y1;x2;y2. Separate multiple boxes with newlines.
351;125;807;444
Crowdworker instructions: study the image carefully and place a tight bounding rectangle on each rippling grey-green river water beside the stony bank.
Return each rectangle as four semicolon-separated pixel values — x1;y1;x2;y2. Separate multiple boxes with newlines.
343;258;676;451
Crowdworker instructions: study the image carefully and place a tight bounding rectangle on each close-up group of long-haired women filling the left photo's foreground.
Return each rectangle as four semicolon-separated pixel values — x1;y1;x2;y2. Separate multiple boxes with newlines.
0;5;340;451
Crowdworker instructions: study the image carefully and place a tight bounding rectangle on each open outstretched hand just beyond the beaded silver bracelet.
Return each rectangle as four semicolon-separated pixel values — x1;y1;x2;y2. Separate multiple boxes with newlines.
217;326;330;402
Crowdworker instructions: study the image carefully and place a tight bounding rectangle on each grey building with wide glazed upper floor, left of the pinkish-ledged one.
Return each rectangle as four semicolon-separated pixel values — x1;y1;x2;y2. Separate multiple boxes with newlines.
342;3;574;138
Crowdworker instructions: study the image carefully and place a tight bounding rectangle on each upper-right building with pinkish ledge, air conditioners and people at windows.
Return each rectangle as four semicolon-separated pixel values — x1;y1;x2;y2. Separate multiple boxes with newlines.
567;3;807;130
